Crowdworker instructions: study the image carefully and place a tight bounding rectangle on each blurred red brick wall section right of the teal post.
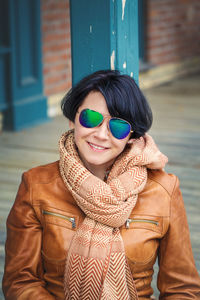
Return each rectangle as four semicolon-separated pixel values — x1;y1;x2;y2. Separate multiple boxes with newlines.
146;0;200;65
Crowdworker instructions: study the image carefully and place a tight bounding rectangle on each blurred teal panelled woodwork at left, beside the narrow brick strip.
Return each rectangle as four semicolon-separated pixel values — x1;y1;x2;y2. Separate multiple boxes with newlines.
0;0;48;130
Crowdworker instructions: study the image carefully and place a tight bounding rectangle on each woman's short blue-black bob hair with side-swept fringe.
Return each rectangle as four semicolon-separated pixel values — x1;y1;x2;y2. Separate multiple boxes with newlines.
61;70;153;138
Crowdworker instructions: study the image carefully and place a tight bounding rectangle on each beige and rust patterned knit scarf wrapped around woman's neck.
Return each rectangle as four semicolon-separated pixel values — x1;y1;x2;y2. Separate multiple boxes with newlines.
59;131;167;300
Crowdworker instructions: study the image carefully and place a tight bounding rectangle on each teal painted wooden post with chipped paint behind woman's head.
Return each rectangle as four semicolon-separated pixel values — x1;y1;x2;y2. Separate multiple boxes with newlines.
70;0;139;85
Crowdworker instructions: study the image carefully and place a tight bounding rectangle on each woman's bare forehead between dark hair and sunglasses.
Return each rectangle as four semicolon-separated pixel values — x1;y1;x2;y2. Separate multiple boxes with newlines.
79;91;110;115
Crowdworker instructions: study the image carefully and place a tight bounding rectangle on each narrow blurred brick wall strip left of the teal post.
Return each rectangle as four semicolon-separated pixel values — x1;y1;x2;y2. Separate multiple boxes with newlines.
41;0;71;96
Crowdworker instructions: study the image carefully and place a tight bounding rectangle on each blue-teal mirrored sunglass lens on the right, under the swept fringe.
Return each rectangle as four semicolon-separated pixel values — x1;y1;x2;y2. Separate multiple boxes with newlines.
109;119;131;140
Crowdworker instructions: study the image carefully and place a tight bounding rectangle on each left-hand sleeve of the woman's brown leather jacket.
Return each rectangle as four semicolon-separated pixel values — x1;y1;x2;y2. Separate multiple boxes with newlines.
3;173;55;300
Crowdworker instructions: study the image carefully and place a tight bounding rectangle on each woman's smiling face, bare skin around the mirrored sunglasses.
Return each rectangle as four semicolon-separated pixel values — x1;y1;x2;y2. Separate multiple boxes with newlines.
70;91;130;176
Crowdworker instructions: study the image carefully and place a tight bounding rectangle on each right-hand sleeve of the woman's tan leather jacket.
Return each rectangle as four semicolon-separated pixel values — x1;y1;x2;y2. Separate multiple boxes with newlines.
158;179;200;300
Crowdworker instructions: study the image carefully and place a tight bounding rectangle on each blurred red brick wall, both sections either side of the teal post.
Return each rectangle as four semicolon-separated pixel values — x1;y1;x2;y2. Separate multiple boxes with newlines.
41;0;200;96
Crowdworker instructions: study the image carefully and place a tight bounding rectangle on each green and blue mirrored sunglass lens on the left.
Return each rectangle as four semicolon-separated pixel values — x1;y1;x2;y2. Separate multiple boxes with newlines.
79;109;103;128
